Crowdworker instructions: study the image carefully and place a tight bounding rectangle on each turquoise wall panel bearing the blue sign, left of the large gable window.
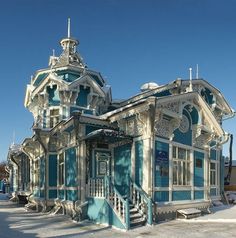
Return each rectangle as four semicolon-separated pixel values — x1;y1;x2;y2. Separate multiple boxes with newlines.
154;141;169;189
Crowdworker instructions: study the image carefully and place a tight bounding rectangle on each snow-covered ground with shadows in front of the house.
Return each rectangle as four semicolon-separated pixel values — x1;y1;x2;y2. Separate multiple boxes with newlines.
0;194;236;238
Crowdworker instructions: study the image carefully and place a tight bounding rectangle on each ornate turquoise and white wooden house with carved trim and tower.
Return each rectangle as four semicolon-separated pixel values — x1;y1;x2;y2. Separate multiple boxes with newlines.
6;20;233;229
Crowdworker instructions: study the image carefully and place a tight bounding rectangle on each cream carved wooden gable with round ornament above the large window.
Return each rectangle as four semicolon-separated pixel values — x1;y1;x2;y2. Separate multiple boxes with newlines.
154;92;223;148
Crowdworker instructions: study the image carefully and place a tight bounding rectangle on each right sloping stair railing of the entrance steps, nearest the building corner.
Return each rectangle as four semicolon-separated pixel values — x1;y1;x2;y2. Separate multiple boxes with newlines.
130;179;153;225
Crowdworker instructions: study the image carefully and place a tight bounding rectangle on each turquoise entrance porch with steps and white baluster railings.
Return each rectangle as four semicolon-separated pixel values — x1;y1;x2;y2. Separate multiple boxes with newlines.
86;176;153;230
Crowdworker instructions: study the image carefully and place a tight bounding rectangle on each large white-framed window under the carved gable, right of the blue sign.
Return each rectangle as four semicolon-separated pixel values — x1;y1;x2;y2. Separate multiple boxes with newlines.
173;146;190;186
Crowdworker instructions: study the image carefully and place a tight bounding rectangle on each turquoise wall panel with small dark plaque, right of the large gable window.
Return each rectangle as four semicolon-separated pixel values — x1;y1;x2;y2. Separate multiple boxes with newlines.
194;151;204;187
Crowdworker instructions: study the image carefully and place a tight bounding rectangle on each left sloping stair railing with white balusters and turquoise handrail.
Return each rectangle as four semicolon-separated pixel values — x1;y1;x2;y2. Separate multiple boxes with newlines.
105;176;130;230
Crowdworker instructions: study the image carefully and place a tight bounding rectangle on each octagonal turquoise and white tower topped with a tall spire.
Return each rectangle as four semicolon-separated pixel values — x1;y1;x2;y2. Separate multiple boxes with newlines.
25;18;111;128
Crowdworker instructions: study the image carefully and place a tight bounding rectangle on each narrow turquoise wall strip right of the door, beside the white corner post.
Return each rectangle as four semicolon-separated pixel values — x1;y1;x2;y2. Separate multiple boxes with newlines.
135;140;143;186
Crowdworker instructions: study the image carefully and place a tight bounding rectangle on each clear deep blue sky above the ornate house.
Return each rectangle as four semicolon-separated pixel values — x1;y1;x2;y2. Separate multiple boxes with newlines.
0;0;236;161
